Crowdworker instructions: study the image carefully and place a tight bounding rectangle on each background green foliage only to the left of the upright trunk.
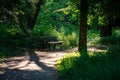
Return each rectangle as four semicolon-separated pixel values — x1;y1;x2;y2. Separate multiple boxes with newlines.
0;0;79;52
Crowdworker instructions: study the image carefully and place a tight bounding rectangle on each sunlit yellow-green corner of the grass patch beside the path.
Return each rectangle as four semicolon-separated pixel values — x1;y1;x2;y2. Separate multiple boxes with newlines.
57;53;80;77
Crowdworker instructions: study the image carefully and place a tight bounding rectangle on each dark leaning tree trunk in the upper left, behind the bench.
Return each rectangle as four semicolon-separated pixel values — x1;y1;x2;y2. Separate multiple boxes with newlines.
28;0;42;29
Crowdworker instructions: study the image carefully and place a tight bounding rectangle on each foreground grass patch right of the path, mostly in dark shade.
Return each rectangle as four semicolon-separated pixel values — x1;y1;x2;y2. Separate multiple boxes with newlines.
57;45;120;80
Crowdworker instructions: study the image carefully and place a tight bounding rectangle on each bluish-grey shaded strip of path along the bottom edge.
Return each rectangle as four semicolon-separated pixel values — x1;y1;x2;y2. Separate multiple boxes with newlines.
0;69;57;80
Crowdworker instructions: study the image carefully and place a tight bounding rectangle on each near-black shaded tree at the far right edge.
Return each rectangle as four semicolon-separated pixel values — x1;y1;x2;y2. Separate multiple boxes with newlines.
101;0;120;37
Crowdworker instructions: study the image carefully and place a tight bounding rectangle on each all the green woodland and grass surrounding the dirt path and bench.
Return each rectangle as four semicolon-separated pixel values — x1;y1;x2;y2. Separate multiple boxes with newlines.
0;0;120;80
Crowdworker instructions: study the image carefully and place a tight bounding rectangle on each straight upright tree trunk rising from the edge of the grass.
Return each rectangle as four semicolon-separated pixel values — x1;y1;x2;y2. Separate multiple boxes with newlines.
78;0;88;54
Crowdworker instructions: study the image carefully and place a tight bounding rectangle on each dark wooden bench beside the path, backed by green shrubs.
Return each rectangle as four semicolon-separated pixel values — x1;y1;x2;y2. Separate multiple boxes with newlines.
43;36;63;50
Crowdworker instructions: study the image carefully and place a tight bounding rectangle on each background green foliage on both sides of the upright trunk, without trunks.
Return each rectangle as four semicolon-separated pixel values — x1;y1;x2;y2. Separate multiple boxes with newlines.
0;0;120;60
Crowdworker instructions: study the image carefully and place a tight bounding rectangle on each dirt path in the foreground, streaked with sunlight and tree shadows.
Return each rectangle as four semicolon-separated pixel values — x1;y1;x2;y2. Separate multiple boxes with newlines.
0;51;66;80
